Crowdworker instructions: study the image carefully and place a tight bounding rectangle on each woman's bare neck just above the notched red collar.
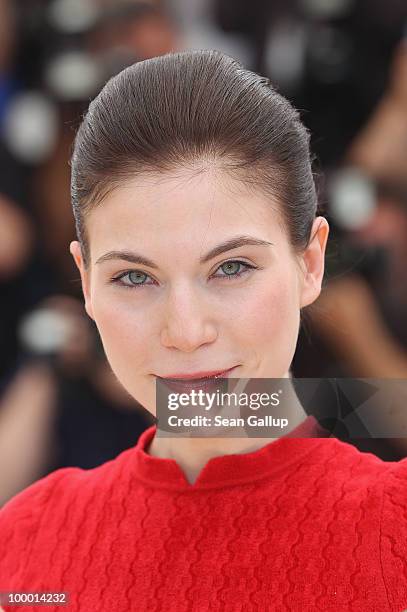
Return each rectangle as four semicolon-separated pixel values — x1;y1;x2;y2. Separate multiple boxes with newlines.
146;373;307;484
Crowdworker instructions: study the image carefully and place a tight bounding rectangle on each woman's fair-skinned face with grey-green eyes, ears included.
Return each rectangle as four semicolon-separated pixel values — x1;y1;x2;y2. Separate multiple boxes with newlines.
70;168;329;414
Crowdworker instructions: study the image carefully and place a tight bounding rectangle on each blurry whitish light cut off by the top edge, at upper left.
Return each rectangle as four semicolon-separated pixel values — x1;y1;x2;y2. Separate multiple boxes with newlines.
48;0;99;34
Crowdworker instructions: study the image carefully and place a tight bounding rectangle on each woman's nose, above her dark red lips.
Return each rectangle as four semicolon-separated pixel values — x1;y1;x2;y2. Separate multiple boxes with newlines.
161;285;218;353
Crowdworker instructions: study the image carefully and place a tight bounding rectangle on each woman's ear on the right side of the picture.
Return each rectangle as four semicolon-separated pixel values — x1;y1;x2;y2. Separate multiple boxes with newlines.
300;217;329;308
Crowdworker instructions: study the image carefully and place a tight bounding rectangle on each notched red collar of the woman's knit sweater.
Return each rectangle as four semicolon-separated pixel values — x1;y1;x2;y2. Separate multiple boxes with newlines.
134;416;329;491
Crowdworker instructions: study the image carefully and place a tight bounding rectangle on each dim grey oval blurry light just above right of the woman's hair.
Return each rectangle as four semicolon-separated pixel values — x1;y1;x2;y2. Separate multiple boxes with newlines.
265;21;307;91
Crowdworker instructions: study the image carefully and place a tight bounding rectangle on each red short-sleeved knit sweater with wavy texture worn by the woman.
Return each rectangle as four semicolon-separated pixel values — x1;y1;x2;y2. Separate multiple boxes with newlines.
0;417;407;612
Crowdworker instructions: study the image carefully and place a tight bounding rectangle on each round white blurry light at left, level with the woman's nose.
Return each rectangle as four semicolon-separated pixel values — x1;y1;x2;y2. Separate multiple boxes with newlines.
18;308;72;354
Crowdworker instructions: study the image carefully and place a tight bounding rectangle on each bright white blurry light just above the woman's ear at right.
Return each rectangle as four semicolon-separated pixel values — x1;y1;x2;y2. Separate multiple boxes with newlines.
329;168;376;230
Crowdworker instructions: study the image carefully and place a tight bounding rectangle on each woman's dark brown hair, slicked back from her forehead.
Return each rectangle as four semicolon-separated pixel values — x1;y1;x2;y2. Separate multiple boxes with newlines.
71;51;317;267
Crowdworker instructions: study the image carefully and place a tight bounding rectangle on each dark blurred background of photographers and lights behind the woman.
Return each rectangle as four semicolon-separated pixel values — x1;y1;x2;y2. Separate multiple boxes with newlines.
0;0;407;505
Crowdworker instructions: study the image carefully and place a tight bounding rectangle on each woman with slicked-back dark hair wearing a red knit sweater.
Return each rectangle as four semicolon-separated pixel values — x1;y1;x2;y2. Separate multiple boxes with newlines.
0;51;407;612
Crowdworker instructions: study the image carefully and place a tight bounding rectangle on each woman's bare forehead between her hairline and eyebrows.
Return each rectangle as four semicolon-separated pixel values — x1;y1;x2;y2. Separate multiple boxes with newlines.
87;167;282;257
